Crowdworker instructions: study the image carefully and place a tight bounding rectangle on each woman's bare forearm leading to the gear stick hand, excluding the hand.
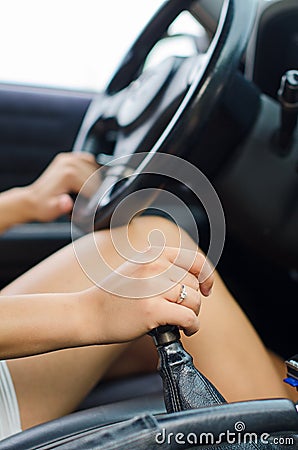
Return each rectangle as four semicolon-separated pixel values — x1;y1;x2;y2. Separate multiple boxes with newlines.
0;294;86;359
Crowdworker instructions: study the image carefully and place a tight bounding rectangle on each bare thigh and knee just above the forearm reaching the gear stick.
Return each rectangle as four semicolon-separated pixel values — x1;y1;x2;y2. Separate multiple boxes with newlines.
1;216;184;295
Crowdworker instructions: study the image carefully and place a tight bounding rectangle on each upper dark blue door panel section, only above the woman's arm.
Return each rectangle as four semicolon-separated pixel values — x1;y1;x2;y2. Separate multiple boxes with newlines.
0;85;91;191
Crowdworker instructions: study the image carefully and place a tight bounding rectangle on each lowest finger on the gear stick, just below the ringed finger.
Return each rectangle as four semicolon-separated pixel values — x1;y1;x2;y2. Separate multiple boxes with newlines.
157;301;200;336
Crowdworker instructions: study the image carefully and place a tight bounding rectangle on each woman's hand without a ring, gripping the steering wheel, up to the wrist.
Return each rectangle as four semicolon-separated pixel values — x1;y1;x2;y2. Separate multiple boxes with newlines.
23;152;99;222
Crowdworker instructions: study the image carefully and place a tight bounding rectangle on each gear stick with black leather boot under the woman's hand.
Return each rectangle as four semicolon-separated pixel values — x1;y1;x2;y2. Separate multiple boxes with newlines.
149;325;226;413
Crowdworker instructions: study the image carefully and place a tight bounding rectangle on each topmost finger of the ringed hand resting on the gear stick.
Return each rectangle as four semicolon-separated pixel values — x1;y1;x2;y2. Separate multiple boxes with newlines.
164;247;214;296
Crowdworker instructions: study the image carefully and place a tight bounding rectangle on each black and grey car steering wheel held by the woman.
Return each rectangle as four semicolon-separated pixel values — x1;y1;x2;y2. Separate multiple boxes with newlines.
73;0;257;231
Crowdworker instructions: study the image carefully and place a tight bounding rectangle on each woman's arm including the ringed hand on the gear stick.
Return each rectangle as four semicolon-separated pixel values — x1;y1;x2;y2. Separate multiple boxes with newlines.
0;248;213;359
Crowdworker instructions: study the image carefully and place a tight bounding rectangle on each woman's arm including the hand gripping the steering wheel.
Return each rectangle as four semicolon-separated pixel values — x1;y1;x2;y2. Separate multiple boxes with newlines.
0;152;99;233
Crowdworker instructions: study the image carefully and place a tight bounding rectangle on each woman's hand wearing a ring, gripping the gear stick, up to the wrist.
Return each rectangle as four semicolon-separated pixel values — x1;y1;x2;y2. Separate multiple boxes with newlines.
81;247;213;344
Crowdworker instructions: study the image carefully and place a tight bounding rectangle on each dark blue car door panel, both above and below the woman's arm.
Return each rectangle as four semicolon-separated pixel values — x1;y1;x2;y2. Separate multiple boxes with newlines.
0;84;92;287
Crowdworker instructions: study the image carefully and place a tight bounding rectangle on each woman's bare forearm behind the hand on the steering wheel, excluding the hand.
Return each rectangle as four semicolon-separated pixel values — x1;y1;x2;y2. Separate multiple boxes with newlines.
0;188;32;233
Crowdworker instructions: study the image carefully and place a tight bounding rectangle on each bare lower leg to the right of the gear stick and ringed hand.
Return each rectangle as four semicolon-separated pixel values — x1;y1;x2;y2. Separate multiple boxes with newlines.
180;276;295;402
